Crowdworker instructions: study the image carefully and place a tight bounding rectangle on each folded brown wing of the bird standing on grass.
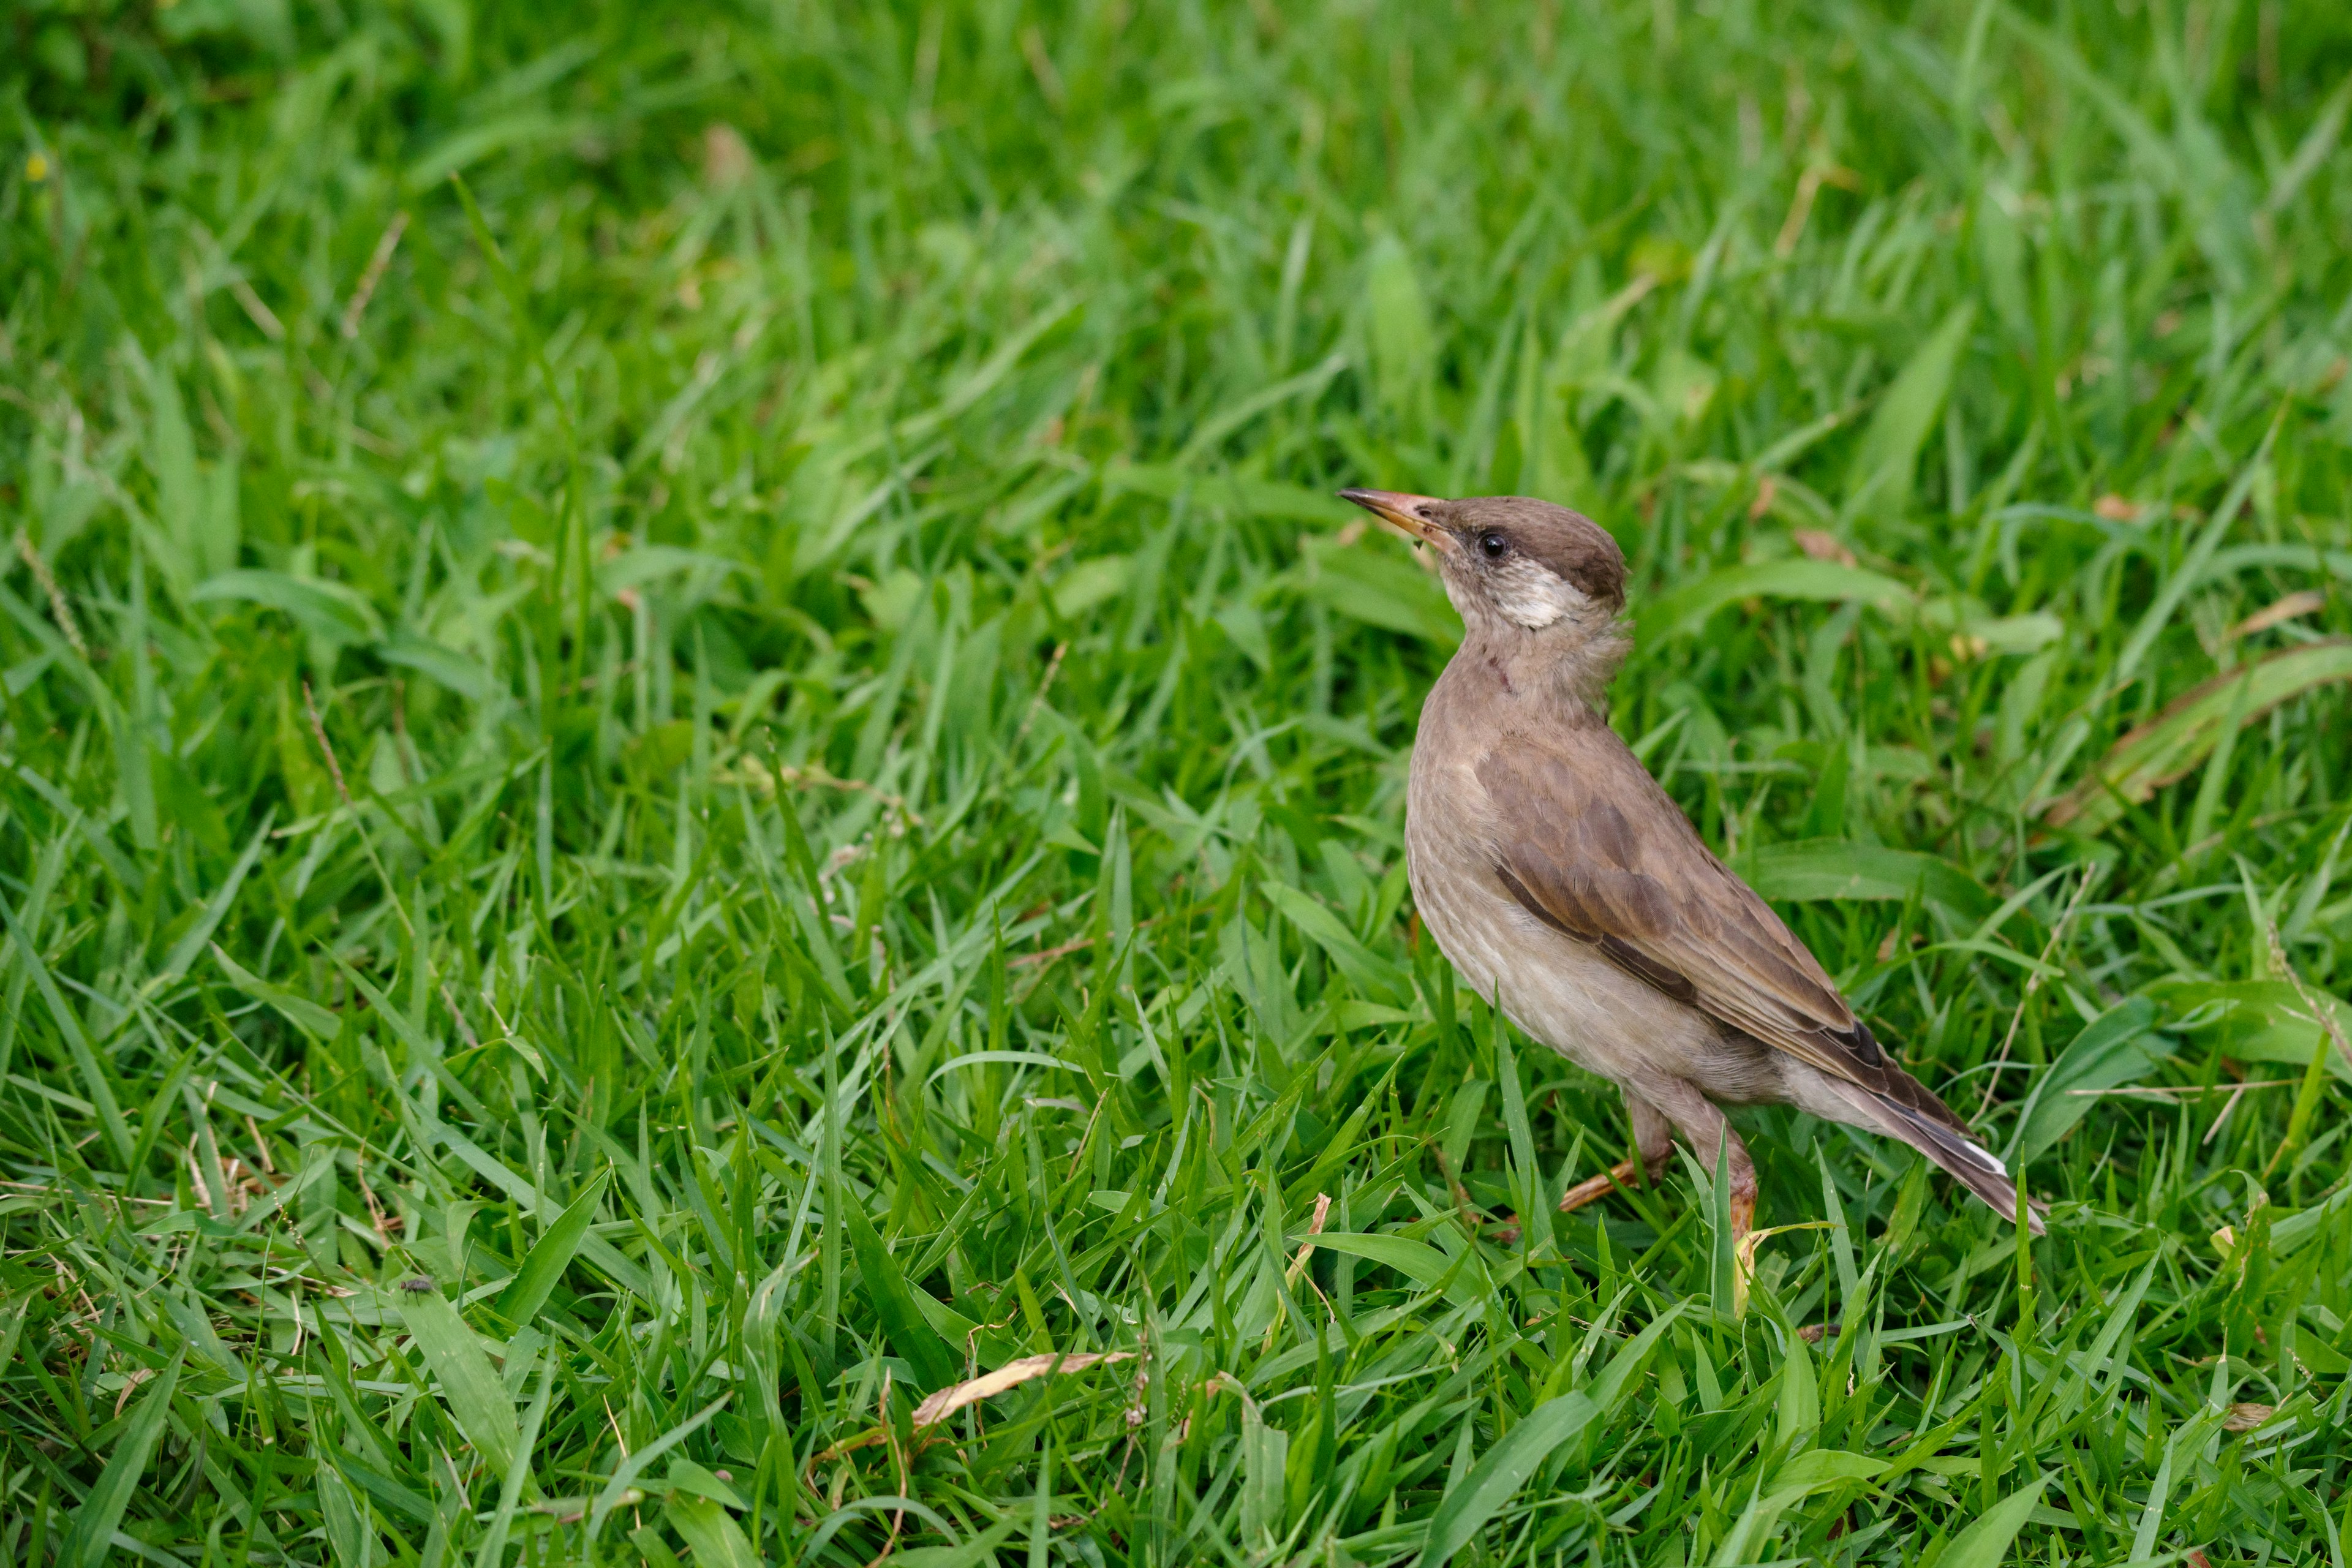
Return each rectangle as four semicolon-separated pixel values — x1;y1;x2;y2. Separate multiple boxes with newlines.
1477;724;1962;1128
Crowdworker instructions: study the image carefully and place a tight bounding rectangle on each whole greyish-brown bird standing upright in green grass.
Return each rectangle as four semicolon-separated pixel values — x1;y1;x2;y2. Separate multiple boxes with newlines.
1341;489;2041;1272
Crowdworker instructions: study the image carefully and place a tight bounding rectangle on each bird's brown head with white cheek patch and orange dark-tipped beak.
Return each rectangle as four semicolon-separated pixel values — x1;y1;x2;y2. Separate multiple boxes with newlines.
1341;489;1625;663
